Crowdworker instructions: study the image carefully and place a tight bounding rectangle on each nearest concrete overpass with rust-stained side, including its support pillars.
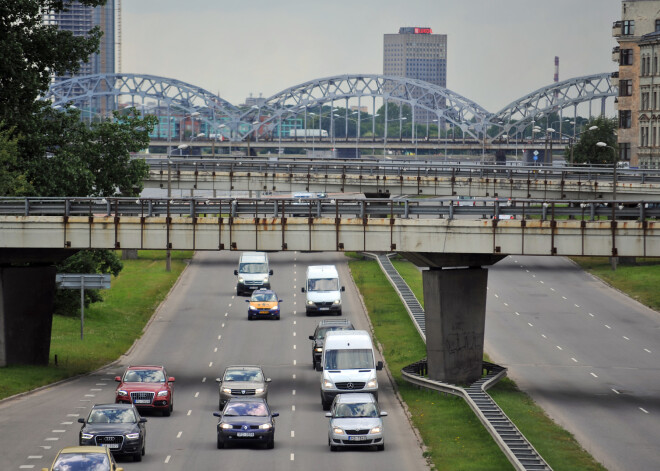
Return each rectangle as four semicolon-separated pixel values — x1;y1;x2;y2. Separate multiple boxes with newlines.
0;198;660;383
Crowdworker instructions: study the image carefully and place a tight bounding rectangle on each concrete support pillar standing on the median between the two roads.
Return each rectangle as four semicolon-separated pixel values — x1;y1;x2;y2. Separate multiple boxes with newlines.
422;267;488;384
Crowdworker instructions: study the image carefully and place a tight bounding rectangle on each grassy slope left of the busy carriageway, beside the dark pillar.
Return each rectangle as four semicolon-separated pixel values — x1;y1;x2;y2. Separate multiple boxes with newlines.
0;251;192;399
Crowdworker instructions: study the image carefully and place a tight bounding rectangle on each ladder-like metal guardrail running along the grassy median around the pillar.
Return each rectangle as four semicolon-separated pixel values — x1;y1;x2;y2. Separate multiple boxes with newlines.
370;254;552;471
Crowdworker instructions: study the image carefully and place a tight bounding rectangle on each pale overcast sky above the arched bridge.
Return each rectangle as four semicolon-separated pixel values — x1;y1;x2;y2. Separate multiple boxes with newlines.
121;0;621;112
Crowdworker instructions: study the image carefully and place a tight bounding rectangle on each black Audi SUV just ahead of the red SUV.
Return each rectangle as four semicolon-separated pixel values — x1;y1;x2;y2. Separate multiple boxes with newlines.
78;404;147;461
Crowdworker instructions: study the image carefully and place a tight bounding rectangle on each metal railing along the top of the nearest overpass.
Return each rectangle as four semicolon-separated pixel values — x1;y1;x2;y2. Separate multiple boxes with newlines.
0;197;660;221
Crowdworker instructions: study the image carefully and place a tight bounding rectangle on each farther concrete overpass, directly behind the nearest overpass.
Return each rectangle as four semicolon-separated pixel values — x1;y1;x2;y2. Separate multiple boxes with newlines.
144;158;660;200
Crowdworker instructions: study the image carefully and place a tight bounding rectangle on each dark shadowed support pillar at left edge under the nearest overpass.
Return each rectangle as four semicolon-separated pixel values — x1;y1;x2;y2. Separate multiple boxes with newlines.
0;266;56;366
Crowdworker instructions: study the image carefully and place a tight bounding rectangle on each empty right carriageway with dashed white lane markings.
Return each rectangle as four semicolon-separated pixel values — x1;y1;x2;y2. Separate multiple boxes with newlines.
485;256;660;471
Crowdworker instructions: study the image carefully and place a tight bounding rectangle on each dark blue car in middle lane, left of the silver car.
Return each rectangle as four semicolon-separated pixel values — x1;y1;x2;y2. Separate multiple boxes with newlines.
213;398;279;448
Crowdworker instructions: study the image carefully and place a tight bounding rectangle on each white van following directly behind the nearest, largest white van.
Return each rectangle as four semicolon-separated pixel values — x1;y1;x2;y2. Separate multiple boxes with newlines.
300;265;346;316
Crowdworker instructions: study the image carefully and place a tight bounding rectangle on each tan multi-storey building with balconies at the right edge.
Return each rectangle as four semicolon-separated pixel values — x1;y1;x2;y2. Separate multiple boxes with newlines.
612;0;660;168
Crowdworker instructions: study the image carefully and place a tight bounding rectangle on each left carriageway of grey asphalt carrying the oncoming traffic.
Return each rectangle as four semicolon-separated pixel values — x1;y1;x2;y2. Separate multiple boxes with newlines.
0;252;428;471
